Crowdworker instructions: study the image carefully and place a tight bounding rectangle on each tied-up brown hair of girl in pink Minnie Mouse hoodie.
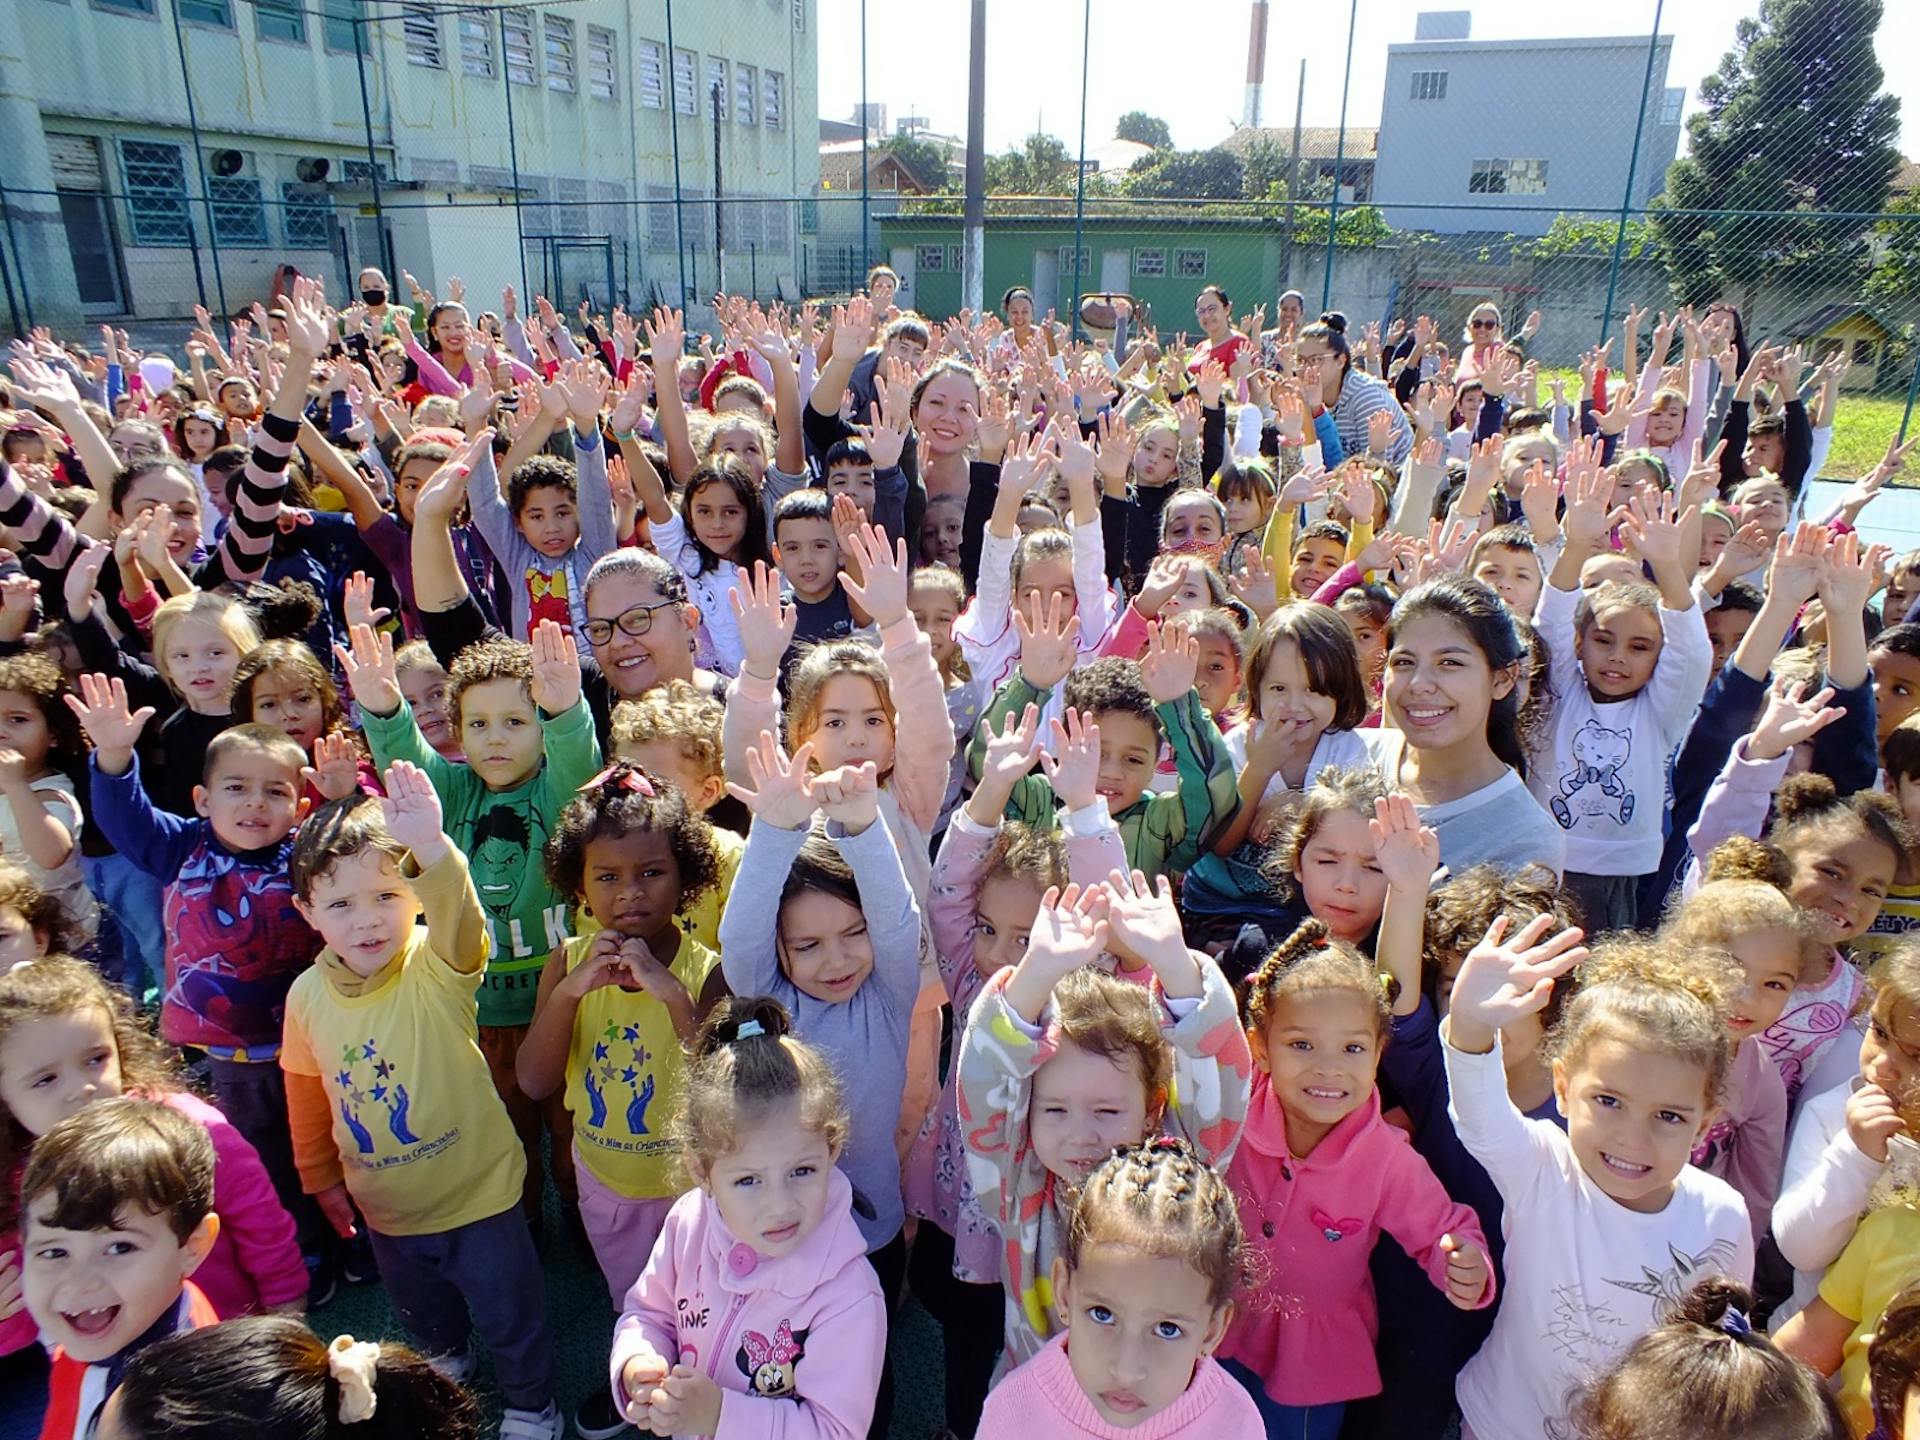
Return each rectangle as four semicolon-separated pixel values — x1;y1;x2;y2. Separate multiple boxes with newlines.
672;995;851;1173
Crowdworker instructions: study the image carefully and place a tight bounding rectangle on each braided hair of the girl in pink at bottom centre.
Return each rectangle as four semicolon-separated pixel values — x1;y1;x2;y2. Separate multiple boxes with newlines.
1060;1139;1248;1309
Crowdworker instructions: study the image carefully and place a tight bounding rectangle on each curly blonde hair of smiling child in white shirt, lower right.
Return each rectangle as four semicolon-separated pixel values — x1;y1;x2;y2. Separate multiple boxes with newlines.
1544;939;1745;1106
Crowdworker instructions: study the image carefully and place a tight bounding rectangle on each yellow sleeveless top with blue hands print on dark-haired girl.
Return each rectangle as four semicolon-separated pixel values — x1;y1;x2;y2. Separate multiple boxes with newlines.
566;935;720;1200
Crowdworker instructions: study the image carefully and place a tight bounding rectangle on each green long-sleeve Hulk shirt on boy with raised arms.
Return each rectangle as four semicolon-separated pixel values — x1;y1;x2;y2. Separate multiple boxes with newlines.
361;699;601;1025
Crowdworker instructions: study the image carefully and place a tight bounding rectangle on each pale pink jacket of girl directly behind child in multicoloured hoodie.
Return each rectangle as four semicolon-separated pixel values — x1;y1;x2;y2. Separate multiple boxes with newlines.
900;810;1121;1284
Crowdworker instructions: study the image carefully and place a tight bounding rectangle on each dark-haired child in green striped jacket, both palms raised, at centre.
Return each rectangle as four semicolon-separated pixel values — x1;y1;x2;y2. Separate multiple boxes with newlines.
968;595;1240;876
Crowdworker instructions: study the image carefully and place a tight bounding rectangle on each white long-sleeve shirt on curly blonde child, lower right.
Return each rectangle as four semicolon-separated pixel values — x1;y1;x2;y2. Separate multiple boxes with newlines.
1444;1041;1753;1440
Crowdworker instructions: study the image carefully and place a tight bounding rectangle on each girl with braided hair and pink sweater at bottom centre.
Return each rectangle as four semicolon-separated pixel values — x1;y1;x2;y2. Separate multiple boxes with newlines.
973;1139;1267;1440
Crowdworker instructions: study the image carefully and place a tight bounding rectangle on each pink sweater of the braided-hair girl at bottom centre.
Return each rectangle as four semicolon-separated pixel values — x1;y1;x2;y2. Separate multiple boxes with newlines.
973;1334;1267;1440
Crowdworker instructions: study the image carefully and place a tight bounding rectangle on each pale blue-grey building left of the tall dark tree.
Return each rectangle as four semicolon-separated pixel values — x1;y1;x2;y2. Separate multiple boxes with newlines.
1373;36;1680;234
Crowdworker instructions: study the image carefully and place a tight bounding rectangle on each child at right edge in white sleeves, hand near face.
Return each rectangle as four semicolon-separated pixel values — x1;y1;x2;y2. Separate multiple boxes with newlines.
1774;941;1920;1319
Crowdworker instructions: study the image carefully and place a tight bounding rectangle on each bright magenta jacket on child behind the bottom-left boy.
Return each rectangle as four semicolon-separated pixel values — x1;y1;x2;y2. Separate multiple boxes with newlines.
0;1091;307;1356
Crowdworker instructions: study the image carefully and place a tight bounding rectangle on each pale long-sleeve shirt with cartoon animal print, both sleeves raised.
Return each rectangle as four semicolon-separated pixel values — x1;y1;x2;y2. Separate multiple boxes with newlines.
1526;586;1713;876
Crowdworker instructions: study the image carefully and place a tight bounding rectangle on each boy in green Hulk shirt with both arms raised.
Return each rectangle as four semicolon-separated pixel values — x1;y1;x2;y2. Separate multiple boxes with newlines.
338;620;601;1217
